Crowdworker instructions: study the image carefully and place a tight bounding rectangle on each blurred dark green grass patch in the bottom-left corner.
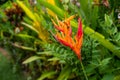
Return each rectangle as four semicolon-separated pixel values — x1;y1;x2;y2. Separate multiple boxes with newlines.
0;52;24;80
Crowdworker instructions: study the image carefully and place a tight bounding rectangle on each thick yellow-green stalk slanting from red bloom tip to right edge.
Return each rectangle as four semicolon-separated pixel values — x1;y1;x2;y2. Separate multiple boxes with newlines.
83;25;120;58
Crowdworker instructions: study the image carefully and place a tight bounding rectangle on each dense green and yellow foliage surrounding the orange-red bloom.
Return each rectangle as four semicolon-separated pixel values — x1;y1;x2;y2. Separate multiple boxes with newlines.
0;0;120;80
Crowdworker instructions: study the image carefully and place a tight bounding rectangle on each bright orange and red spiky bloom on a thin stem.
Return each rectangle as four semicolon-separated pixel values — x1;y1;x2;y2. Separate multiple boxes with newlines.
52;15;83;60
